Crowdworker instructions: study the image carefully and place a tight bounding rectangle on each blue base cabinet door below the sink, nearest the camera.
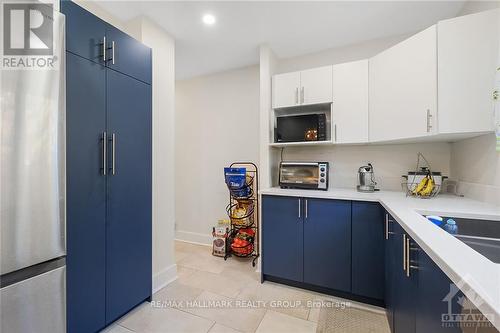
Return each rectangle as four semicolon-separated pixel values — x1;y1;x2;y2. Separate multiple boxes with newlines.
416;251;463;333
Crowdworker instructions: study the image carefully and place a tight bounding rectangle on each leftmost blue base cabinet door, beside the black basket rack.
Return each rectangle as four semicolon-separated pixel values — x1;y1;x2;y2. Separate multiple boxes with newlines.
262;196;304;282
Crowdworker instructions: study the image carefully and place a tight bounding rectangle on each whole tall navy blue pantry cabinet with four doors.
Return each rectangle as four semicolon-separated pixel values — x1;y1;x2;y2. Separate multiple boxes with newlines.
61;1;152;332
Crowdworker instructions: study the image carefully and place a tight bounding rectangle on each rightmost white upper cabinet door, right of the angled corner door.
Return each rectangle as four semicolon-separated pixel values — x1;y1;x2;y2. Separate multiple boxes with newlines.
437;10;500;133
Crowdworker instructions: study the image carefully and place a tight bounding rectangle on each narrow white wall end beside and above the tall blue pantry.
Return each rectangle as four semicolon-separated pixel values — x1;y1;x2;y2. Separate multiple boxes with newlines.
71;0;177;291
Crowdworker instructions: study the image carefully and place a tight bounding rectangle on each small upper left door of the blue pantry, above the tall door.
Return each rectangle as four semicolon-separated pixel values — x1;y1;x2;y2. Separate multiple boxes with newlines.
61;0;106;64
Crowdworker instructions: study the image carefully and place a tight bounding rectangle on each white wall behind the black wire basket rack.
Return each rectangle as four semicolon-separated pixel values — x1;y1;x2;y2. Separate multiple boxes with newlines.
175;66;260;244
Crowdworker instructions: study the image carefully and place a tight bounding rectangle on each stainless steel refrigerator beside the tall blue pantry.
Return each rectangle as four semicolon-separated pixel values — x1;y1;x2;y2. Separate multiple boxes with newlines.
0;7;66;333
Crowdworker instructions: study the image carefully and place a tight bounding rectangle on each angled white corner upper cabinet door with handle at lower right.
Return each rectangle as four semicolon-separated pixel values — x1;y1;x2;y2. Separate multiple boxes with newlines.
369;26;437;141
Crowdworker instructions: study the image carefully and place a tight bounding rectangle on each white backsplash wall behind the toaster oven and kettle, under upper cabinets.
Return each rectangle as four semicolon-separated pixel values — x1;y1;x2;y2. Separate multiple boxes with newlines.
283;143;450;191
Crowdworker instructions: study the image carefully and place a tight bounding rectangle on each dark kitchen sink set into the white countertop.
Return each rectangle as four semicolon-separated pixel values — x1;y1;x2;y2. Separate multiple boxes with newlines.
431;216;500;264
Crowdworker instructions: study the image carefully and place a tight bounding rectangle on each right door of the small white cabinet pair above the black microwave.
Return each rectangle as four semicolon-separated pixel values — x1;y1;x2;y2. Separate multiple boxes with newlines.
300;66;332;104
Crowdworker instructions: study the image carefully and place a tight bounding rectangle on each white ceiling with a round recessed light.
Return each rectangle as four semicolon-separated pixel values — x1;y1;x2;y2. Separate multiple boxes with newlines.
99;1;464;79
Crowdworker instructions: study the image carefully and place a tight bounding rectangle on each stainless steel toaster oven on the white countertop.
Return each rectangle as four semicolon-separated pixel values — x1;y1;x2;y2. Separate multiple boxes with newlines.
279;162;328;191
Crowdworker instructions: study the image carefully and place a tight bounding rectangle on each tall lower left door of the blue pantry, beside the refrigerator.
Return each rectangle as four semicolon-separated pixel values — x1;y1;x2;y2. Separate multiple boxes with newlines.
66;52;106;333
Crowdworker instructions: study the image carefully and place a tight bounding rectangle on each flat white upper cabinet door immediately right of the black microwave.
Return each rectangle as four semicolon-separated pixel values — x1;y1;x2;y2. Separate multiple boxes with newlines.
332;60;368;143
